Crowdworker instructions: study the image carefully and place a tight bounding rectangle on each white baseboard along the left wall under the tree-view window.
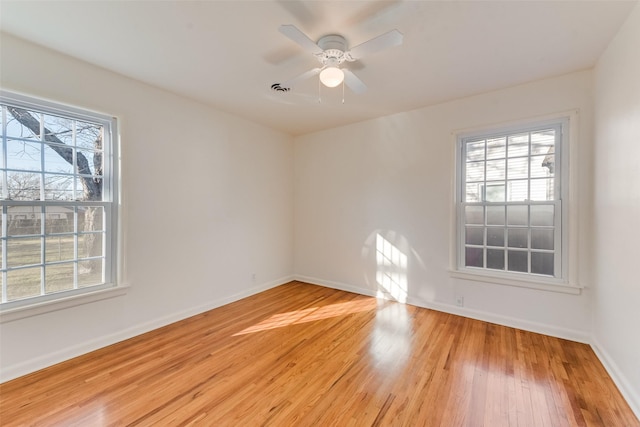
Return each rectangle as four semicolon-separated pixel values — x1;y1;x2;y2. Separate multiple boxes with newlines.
0;276;294;383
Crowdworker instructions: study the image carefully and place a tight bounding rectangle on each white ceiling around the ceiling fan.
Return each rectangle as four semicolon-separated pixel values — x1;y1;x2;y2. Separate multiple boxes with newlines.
0;0;637;135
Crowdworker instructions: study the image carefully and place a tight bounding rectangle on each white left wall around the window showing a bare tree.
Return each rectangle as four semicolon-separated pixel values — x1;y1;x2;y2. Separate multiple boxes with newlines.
0;35;293;380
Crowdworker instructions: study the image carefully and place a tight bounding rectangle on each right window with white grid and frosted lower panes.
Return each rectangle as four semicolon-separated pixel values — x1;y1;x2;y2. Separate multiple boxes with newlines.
457;119;568;282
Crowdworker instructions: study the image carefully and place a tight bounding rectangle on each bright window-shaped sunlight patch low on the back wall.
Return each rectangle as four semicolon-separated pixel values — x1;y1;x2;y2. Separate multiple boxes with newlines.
376;234;408;303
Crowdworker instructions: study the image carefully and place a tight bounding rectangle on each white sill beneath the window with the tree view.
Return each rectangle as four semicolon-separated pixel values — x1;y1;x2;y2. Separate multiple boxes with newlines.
0;285;130;323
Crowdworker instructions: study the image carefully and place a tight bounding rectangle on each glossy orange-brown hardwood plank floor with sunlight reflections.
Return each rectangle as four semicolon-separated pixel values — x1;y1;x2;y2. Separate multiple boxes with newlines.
0;282;640;427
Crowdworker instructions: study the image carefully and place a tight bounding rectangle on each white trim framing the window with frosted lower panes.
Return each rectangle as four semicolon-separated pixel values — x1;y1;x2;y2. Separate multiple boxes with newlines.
449;110;583;294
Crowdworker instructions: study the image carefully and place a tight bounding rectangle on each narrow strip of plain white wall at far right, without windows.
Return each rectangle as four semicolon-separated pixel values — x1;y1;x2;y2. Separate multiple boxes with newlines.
592;2;640;417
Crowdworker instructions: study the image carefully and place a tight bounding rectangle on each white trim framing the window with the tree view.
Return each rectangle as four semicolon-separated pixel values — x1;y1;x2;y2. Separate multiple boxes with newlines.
0;90;129;323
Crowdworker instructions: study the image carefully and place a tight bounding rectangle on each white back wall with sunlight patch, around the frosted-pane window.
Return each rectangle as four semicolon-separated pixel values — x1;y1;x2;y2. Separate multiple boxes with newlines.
294;71;592;341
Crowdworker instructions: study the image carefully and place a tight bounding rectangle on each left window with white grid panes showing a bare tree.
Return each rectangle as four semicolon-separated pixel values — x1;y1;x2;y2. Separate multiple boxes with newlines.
0;92;117;309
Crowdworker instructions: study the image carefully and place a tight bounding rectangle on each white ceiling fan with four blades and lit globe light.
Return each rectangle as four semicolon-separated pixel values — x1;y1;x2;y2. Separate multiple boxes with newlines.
271;24;403;93
